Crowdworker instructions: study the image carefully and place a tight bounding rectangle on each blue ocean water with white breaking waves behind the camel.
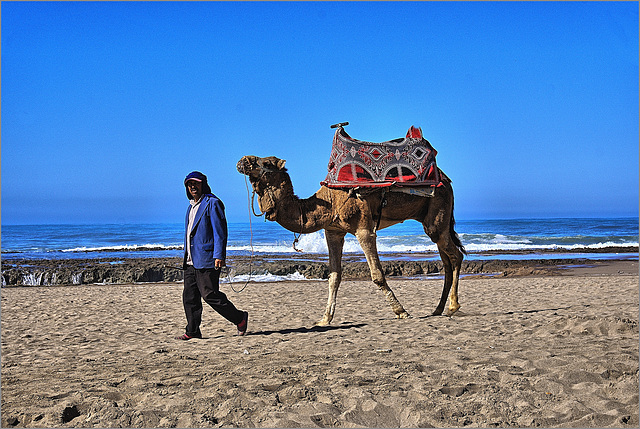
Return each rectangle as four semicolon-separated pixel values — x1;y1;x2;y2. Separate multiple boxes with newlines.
1;218;638;260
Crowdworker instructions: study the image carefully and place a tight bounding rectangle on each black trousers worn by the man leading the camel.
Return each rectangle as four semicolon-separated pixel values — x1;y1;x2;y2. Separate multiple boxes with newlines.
182;265;244;337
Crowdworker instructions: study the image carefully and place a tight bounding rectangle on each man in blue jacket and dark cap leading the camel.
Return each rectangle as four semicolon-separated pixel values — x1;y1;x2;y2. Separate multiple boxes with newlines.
176;171;249;340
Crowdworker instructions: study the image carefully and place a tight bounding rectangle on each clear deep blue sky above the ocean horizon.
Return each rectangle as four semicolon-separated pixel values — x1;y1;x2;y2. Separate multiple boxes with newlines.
1;2;639;224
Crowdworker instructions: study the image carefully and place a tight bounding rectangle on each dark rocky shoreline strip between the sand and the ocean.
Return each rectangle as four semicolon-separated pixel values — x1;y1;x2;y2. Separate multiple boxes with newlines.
2;248;637;287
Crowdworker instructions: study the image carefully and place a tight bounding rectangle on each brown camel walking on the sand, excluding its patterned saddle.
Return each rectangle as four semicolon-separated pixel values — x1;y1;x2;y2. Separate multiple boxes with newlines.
237;155;465;326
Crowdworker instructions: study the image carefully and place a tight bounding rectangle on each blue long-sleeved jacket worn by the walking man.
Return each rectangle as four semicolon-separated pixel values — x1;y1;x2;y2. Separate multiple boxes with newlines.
184;194;227;269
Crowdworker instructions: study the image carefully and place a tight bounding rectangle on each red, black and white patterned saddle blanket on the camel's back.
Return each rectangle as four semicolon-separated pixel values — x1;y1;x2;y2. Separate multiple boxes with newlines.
320;126;444;188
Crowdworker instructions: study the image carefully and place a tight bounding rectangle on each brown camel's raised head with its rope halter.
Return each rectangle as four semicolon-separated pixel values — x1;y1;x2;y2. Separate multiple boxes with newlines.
236;155;293;220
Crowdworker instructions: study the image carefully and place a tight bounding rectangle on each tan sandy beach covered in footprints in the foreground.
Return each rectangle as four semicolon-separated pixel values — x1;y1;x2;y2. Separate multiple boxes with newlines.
1;261;639;427
